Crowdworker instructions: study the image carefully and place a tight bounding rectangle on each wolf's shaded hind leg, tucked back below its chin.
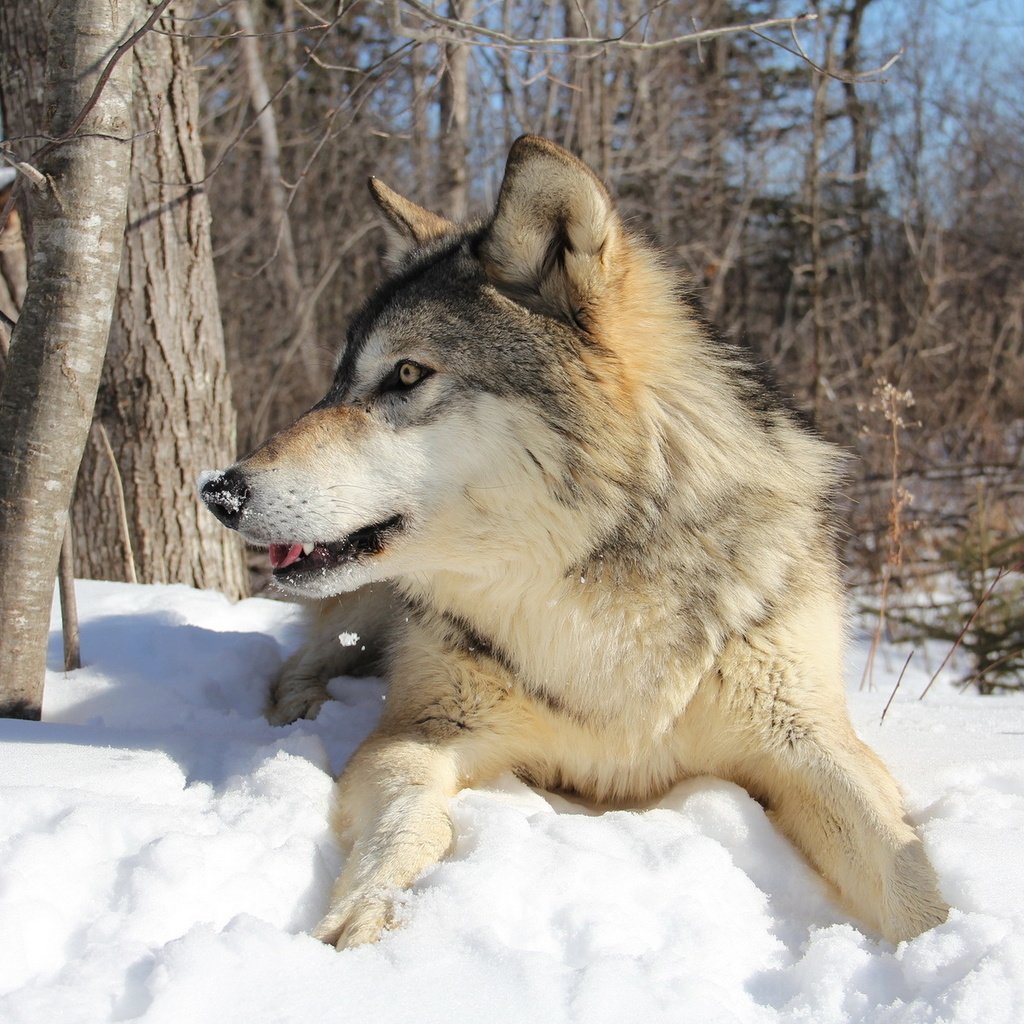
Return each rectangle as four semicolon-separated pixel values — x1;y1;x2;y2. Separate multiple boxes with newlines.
265;584;397;725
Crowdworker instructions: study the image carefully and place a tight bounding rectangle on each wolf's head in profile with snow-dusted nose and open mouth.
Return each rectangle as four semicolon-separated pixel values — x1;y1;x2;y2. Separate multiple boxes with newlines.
200;136;761;595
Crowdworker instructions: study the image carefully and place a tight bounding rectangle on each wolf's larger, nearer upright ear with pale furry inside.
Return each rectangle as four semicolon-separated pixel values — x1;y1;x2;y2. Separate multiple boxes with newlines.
479;135;623;327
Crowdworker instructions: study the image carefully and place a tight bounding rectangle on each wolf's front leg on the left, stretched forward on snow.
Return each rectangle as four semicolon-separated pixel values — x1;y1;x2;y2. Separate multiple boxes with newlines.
313;638;520;948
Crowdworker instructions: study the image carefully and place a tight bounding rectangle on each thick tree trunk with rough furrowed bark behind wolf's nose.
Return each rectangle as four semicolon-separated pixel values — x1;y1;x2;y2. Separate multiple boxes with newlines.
73;4;248;598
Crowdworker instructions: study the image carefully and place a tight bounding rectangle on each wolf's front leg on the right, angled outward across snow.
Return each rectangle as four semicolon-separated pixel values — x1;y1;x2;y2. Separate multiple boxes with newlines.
716;659;948;942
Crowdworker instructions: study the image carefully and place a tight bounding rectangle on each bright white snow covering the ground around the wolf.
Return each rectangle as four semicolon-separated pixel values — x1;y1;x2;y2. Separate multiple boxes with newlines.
0;583;1024;1024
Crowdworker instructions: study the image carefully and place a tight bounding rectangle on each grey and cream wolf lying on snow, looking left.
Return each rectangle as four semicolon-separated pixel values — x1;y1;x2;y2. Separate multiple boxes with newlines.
201;136;948;948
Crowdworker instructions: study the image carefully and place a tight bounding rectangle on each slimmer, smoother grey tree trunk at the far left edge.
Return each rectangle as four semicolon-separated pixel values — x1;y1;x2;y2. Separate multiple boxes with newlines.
0;0;135;719
